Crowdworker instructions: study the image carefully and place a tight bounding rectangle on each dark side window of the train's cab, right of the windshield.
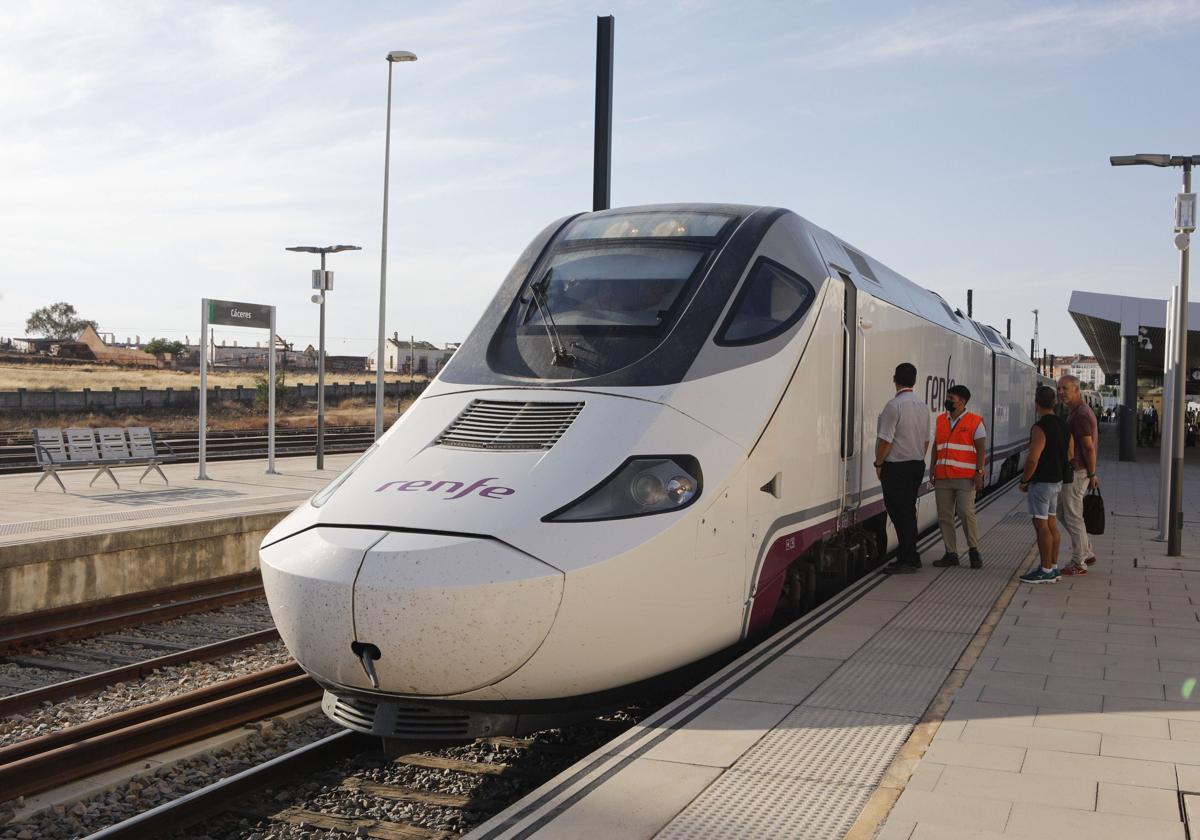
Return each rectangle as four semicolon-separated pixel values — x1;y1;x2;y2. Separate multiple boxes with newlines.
716;257;816;346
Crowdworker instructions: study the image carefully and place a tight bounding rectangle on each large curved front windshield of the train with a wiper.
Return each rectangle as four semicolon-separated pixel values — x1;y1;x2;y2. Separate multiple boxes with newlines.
488;211;733;379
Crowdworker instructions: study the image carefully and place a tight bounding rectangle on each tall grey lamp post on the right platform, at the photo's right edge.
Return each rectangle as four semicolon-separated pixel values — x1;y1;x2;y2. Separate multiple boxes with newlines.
1109;154;1200;557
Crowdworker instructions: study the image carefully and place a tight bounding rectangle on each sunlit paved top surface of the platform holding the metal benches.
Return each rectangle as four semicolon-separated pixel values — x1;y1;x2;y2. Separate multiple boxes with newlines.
0;454;358;546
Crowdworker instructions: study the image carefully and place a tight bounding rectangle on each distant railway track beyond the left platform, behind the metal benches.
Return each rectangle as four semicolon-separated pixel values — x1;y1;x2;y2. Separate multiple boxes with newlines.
0;426;374;474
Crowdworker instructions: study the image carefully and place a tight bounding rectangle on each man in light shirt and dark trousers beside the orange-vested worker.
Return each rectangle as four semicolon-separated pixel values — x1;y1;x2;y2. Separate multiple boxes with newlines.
875;361;930;574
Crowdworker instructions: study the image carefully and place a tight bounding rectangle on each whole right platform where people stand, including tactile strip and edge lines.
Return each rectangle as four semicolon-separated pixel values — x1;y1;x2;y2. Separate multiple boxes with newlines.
468;444;1200;840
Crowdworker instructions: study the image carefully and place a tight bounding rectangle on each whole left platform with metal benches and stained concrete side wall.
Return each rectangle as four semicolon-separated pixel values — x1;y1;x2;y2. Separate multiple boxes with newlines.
0;454;358;619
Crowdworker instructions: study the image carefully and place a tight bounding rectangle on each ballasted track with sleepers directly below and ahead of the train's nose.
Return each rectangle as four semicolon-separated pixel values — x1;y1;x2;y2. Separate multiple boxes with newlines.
91;709;649;840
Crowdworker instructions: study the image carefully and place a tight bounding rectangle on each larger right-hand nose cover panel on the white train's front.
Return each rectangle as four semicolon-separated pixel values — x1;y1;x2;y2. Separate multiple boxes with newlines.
343;533;563;696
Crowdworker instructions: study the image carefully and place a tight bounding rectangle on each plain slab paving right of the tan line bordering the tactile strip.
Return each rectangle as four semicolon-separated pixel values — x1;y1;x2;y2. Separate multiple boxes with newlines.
878;436;1200;840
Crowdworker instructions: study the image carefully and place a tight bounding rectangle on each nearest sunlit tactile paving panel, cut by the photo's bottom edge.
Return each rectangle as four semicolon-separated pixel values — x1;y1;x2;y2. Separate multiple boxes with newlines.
655;769;874;840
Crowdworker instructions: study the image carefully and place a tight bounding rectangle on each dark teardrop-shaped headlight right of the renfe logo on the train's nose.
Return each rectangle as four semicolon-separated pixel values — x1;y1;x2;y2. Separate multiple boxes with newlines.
542;455;701;522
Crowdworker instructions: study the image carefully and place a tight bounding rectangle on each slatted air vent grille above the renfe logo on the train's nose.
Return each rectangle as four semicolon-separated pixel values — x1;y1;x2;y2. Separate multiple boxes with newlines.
436;400;583;449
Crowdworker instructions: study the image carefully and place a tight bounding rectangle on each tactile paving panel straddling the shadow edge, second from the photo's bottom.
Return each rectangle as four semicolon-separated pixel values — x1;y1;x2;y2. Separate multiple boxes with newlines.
737;706;917;787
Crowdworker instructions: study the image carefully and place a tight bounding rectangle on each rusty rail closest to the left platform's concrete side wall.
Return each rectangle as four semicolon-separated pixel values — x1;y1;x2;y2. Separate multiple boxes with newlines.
0;571;263;650
